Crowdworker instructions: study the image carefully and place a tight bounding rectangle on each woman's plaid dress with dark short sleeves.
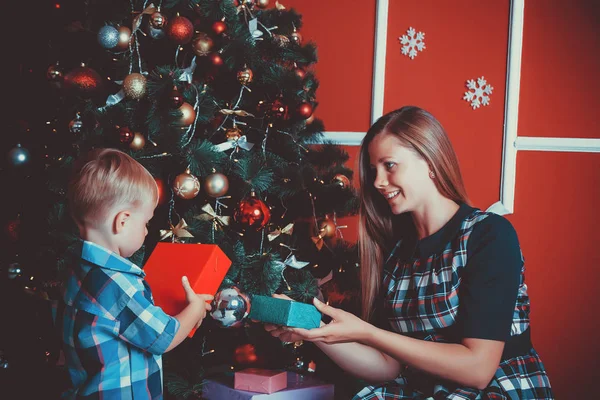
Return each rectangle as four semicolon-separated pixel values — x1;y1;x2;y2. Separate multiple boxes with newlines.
355;204;553;400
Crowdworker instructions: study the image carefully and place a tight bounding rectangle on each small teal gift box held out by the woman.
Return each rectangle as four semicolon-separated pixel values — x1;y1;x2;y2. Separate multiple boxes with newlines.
248;295;321;329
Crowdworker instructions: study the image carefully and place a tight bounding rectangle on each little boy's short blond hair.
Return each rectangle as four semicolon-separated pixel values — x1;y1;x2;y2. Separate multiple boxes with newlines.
67;149;158;226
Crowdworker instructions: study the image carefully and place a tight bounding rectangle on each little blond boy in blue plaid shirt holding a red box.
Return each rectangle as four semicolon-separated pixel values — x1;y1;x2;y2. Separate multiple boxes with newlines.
63;149;213;400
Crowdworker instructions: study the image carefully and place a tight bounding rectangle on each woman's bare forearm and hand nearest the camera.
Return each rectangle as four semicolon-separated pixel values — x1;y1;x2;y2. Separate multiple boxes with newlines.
282;299;504;389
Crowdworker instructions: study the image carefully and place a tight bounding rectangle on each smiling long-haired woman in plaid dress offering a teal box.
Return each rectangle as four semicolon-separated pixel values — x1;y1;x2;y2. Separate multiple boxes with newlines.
265;107;553;399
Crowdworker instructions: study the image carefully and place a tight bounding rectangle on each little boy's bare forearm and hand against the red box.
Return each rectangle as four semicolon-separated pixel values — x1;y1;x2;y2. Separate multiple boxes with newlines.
165;276;213;352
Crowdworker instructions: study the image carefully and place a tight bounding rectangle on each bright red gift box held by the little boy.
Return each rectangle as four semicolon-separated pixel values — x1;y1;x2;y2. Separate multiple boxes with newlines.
144;242;231;337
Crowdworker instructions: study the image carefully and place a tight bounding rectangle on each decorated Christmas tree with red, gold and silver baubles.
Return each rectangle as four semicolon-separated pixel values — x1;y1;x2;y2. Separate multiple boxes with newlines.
0;0;357;397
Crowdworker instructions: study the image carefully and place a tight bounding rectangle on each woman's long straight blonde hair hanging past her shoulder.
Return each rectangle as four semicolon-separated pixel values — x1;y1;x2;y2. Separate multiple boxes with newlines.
358;106;468;321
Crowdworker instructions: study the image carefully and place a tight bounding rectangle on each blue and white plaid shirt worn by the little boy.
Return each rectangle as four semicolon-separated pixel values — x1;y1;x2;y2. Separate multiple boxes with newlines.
63;242;179;400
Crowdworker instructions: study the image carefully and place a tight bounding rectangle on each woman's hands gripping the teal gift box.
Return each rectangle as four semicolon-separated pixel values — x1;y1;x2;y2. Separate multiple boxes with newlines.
265;295;373;344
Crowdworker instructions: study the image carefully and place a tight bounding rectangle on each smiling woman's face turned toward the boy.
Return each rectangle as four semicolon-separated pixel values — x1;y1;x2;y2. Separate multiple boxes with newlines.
368;132;437;214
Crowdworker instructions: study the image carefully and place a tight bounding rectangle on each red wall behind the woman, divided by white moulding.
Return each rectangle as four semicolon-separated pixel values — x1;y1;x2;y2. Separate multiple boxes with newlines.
284;0;600;399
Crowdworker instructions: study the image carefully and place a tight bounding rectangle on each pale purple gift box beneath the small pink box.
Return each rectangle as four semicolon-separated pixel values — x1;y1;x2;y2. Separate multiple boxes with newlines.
202;371;334;400
